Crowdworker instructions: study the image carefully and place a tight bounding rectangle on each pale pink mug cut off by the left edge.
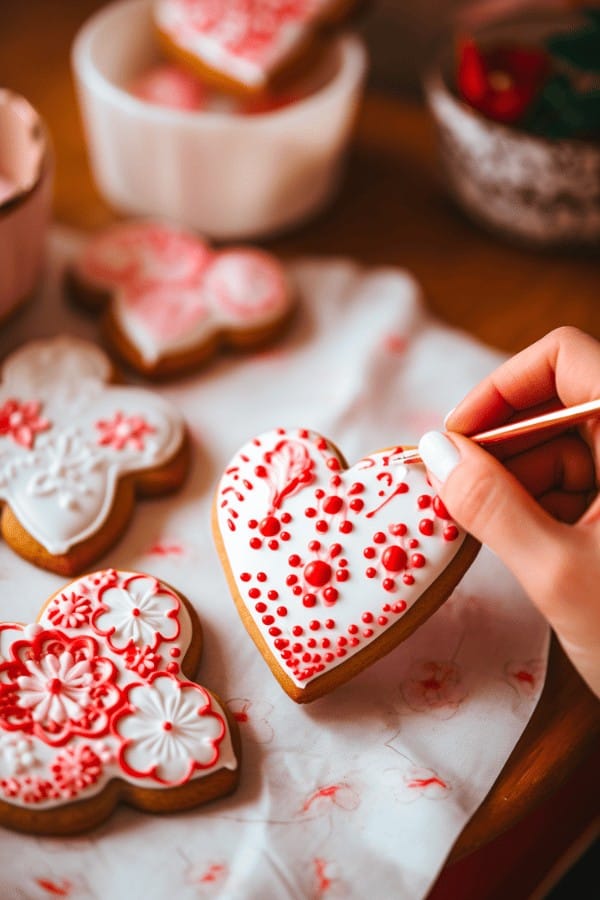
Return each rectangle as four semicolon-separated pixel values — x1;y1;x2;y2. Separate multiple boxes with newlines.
0;88;53;322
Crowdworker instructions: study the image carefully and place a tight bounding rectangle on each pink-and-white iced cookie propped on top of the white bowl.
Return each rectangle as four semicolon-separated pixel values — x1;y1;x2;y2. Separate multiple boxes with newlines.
153;0;356;93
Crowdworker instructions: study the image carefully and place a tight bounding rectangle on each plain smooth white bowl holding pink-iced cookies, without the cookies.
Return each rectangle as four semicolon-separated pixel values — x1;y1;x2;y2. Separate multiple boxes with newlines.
72;0;367;240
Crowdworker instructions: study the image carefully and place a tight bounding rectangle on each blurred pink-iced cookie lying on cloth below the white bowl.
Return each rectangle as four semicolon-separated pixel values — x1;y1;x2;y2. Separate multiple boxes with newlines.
67;220;293;377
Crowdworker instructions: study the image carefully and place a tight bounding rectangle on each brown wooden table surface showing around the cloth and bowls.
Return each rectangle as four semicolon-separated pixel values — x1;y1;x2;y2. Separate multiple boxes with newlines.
0;0;600;872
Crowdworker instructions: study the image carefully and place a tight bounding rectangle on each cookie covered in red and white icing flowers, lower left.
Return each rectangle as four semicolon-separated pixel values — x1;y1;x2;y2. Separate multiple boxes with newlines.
0;569;239;834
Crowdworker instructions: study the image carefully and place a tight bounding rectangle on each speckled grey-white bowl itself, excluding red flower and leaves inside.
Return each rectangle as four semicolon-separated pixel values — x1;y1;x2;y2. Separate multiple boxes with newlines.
425;17;600;248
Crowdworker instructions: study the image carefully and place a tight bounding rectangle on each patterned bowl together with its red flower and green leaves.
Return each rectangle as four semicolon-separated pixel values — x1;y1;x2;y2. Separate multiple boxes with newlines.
425;10;600;248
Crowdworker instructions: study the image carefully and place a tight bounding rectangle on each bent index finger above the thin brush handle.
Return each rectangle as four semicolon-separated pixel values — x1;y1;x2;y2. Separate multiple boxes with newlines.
445;326;600;434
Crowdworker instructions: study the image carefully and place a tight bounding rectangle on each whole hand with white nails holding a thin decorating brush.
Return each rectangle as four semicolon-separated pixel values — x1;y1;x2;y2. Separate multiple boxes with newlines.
419;326;600;696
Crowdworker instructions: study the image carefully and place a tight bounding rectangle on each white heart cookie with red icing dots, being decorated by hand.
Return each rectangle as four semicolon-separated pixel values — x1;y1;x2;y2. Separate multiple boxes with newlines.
213;428;479;703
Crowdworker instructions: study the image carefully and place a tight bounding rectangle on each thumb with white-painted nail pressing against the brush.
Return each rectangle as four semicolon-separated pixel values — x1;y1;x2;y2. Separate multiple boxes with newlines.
419;431;564;593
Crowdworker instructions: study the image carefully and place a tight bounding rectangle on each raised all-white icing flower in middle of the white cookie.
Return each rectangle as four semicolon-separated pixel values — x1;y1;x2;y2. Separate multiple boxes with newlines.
26;429;102;509
